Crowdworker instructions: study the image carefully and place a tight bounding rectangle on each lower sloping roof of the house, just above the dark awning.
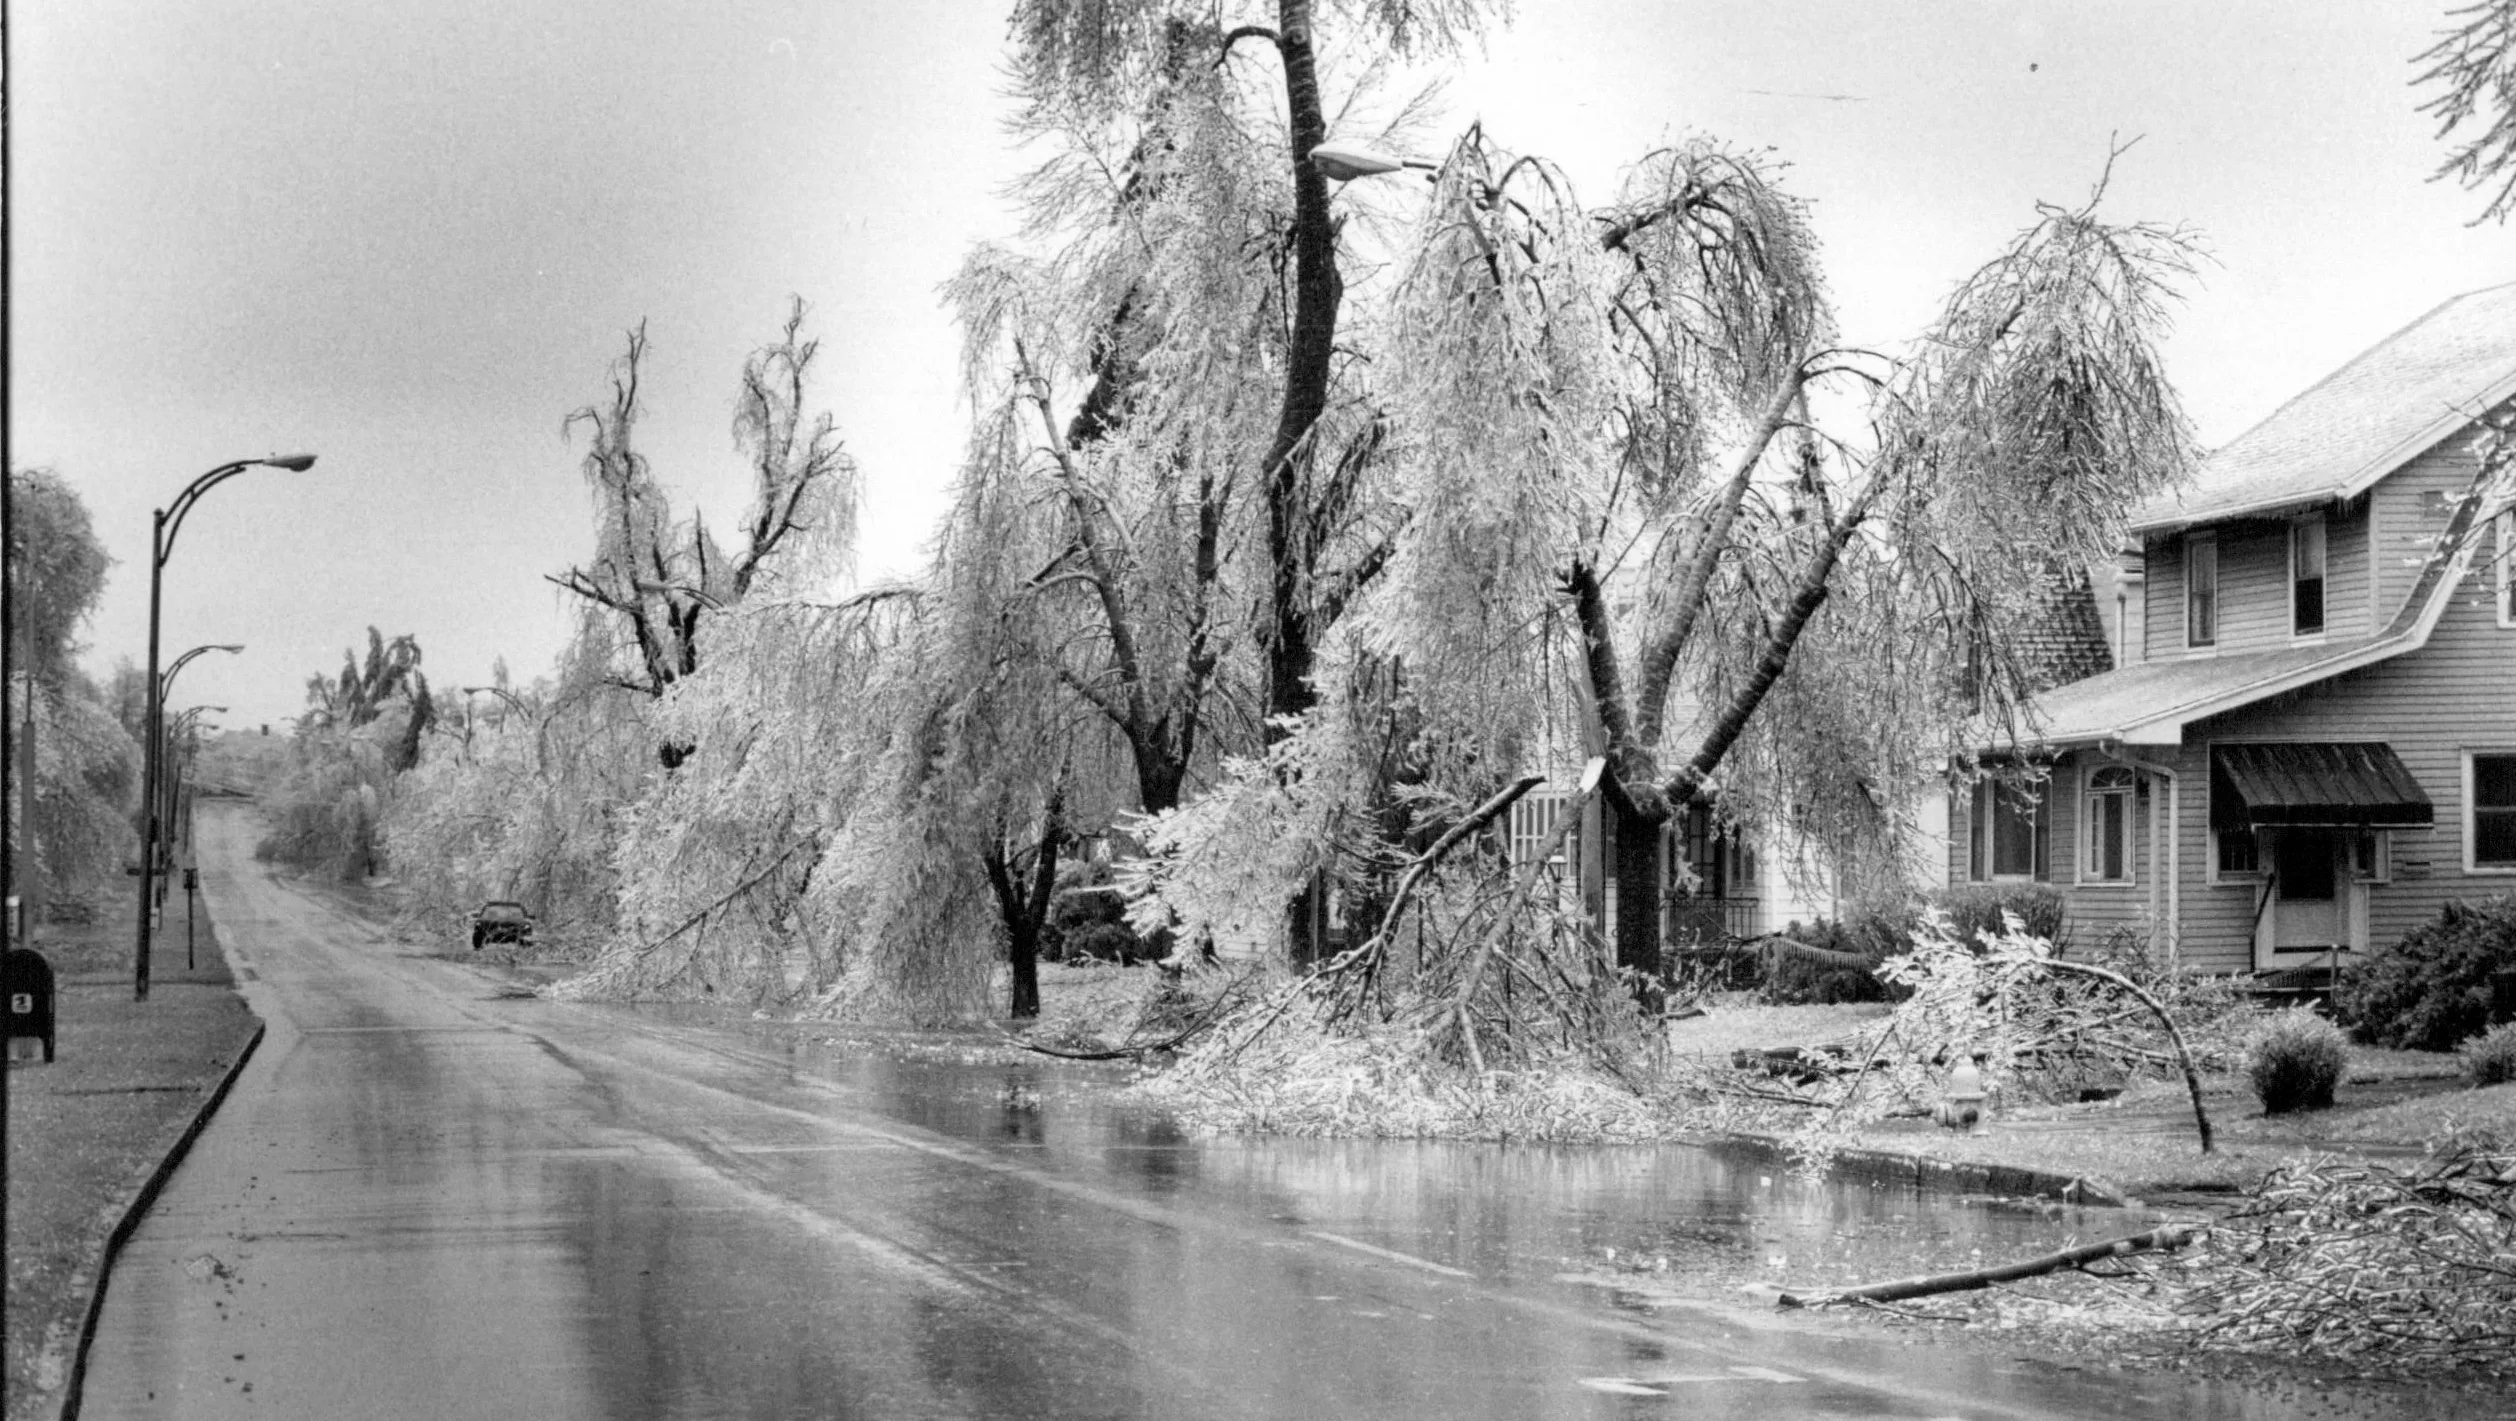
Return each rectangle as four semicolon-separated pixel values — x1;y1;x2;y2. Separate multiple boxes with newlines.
1993;488;2496;749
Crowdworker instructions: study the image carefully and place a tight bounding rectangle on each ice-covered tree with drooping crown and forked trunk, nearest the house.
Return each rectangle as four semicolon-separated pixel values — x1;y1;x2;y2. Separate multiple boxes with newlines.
1366;131;2189;990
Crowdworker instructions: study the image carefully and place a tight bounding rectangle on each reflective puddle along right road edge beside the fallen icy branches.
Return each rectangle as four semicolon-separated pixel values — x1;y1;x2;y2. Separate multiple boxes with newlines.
618;1006;2154;1303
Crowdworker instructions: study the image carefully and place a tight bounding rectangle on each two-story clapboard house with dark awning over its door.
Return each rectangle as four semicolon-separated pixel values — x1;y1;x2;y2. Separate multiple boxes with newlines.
1950;284;2516;971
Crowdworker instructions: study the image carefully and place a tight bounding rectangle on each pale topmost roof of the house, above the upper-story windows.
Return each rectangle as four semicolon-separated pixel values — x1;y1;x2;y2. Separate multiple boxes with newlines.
2131;284;2516;536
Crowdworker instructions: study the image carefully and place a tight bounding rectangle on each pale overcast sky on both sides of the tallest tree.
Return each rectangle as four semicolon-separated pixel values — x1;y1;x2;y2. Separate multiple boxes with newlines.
8;0;2516;727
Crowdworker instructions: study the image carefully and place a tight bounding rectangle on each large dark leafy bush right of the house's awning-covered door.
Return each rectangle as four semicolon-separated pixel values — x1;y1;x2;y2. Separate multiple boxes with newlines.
2332;893;2516;1051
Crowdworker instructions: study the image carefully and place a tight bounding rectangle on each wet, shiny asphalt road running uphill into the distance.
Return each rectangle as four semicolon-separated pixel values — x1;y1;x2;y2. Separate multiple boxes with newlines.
83;810;2435;1421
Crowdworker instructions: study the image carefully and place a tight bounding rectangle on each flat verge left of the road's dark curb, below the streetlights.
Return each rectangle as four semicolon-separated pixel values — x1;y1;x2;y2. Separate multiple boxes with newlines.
5;888;262;1421
